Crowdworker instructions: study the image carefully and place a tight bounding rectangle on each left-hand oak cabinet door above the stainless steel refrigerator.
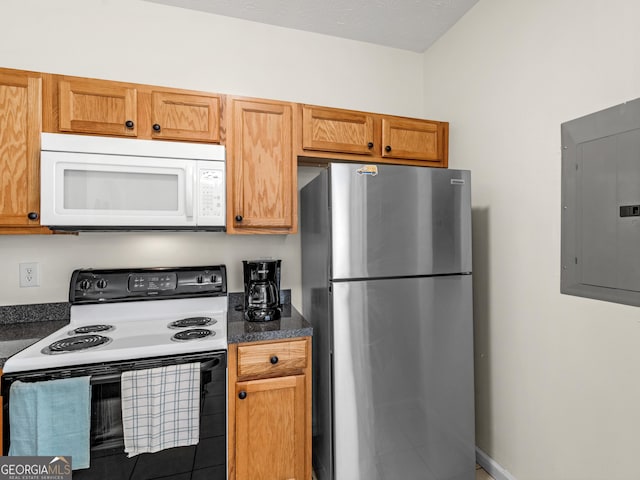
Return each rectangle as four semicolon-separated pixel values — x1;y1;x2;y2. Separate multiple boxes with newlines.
302;105;380;155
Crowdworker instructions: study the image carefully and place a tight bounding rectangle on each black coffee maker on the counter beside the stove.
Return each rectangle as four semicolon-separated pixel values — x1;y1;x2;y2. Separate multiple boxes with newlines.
242;260;282;322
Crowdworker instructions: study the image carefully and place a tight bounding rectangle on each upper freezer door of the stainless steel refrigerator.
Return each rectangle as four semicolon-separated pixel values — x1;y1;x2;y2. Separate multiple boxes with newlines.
330;163;471;279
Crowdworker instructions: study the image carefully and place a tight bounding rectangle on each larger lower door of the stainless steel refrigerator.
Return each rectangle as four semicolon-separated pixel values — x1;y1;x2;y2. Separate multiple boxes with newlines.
332;275;475;480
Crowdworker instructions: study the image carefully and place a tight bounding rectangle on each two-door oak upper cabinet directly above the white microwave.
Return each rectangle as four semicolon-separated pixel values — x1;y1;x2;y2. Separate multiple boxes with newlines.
43;75;221;143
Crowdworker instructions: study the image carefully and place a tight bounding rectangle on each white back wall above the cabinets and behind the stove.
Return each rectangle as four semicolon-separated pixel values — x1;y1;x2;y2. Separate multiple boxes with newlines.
0;0;423;307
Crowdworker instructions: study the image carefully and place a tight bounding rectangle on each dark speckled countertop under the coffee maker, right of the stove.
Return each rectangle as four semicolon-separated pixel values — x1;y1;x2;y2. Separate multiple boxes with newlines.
227;292;313;343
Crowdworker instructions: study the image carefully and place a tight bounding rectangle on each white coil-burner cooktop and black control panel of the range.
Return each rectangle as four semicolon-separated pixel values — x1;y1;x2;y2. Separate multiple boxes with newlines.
3;265;227;373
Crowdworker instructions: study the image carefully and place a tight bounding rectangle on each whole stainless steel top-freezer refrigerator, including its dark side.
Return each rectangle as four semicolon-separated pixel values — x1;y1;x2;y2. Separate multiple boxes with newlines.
300;163;475;480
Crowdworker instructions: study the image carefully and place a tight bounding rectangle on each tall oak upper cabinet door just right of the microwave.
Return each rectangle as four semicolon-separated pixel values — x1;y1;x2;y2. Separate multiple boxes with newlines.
227;99;298;233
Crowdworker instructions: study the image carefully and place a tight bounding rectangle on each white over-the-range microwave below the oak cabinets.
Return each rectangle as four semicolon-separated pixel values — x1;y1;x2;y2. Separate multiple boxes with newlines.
40;133;226;231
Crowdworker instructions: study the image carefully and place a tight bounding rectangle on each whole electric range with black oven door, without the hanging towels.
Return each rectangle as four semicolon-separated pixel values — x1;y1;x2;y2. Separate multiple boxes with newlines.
2;265;227;480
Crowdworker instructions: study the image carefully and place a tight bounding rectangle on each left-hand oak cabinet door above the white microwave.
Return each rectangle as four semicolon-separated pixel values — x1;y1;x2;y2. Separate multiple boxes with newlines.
58;78;138;137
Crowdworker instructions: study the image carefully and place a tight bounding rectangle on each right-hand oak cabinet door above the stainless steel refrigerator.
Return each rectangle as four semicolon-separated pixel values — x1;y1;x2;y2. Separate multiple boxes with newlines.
382;118;445;161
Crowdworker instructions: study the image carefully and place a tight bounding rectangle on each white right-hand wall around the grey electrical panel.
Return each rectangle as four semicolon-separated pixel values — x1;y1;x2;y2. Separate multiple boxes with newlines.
424;0;640;480
